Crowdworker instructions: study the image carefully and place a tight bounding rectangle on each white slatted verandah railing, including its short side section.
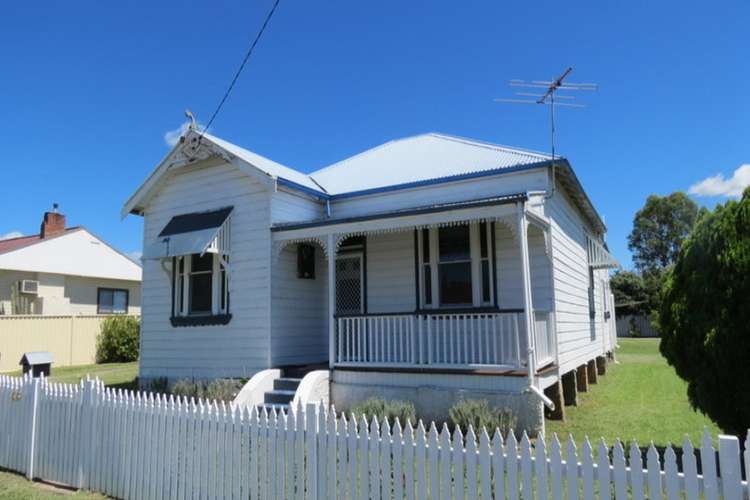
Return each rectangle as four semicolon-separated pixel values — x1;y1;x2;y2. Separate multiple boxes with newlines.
335;310;555;368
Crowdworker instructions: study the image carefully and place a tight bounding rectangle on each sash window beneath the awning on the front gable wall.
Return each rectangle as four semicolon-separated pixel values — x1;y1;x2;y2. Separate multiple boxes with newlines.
172;253;229;317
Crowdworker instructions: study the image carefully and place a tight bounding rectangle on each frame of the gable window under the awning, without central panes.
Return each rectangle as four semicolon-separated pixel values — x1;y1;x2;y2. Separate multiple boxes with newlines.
171;253;231;326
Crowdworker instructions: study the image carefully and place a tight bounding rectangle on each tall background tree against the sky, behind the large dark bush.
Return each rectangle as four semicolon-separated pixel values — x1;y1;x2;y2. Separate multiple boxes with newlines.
628;192;698;273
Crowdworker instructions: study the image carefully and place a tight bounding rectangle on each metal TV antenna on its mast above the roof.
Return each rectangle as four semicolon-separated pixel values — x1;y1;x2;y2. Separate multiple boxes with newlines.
495;67;599;198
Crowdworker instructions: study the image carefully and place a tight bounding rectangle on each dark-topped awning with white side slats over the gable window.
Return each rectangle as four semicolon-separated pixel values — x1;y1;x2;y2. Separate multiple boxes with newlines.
143;207;233;259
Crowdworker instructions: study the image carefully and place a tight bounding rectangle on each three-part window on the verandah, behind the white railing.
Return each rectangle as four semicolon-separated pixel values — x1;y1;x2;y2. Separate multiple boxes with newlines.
417;222;494;308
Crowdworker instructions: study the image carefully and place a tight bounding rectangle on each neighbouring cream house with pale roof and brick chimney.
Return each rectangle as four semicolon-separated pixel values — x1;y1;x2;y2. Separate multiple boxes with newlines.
0;209;141;316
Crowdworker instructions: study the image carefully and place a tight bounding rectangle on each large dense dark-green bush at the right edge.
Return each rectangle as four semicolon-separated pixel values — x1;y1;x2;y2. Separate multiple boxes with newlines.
658;189;750;434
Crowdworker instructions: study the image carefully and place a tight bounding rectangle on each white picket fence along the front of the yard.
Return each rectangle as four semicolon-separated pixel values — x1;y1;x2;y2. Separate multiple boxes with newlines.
0;376;750;500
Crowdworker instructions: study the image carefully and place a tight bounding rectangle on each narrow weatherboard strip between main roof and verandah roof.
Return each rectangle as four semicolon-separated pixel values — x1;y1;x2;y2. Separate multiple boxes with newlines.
331;169;548;218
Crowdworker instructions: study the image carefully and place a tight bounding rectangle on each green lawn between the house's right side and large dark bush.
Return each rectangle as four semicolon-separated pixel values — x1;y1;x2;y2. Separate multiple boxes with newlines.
546;339;720;446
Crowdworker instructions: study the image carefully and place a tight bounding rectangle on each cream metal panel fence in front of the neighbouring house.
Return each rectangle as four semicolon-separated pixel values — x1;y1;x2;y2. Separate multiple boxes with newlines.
0;315;135;372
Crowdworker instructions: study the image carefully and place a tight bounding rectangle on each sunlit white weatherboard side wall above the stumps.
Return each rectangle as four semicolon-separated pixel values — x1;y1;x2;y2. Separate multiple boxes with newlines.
546;189;608;373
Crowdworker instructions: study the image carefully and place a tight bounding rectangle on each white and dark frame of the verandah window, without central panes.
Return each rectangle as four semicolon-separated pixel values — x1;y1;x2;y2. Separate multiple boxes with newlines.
415;221;497;309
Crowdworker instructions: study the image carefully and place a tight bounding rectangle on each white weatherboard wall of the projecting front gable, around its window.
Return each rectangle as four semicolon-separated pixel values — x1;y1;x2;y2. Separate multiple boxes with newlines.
140;160;271;379
